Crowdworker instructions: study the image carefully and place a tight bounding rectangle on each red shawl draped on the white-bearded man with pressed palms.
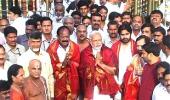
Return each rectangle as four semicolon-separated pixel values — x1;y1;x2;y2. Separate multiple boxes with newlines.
79;45;119;99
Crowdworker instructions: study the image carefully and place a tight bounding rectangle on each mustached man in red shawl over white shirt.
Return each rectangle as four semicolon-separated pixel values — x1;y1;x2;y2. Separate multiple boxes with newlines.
47;26;80;100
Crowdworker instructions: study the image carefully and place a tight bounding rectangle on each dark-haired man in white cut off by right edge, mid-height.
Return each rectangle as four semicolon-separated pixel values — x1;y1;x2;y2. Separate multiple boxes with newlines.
162;35;170;64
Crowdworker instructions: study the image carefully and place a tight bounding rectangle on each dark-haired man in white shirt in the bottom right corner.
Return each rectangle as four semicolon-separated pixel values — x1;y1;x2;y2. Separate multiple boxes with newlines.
152;62;170;100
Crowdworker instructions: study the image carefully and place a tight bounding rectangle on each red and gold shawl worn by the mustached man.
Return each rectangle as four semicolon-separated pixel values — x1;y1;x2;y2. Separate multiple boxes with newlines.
47;40;80;100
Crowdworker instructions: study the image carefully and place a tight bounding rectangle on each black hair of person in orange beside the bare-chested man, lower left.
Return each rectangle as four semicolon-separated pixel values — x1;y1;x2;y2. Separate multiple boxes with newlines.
7;64;23;86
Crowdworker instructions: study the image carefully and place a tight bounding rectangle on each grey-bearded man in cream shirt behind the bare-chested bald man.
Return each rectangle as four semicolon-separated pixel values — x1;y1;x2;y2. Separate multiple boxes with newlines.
17;32;54;100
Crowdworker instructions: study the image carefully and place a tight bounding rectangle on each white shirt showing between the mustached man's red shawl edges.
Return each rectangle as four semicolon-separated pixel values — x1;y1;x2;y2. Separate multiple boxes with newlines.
57;44;70;62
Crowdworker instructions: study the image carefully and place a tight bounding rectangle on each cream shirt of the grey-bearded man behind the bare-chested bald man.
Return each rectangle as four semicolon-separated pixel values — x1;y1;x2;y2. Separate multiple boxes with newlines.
17;49;54;97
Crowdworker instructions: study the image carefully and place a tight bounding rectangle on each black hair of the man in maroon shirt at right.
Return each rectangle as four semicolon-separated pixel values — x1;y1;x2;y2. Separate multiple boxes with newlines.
142;42;161;57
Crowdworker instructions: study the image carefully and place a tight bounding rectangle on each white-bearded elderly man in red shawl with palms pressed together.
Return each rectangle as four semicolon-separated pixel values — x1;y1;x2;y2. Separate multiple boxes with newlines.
79;31;119;100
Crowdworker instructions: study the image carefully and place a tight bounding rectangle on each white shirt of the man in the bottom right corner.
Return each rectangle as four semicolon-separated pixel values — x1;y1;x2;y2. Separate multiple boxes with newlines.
152;83;170;100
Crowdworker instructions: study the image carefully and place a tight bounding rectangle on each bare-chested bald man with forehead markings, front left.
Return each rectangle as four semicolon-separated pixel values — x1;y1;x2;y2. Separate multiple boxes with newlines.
24;59;47;100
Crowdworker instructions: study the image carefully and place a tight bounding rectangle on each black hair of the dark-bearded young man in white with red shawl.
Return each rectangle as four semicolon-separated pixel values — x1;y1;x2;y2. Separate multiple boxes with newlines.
118;23;132;34
